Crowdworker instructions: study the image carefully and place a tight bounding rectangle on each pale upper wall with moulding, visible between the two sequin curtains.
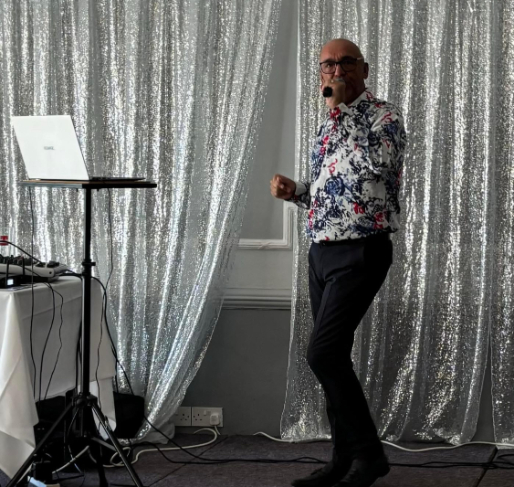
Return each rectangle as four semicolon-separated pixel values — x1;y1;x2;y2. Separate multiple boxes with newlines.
225;0;297;308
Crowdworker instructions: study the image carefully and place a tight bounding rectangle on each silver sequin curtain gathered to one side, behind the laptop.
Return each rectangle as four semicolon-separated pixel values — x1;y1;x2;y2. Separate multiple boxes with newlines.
0;0;280;438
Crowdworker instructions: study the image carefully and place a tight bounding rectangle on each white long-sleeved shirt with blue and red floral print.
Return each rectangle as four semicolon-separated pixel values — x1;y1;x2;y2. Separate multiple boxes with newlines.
290;89;407;242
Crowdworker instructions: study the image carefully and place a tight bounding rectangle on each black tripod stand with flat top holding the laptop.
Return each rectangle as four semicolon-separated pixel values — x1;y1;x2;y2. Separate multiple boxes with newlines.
7;180;157;487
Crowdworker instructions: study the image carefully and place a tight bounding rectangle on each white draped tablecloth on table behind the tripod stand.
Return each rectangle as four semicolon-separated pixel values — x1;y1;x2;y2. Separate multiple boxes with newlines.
0;277;115;477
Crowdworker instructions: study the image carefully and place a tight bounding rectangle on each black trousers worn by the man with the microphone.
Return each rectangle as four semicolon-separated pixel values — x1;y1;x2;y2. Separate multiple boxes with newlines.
307;234;393;462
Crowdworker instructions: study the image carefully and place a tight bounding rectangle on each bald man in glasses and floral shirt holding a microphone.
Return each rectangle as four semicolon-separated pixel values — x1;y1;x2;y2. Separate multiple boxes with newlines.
271;39;406;487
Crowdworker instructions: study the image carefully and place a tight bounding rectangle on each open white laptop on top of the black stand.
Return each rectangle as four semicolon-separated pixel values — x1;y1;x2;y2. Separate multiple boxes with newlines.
12;115;145;181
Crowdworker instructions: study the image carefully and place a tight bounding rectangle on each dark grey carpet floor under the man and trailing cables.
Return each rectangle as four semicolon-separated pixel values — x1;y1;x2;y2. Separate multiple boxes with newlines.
0;435;508;487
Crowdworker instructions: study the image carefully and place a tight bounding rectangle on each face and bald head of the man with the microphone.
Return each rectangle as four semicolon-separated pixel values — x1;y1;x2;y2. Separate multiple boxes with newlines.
320;40;369;104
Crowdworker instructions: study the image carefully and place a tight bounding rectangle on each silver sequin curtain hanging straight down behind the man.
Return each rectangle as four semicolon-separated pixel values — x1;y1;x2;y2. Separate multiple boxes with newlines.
281;0;514;444
